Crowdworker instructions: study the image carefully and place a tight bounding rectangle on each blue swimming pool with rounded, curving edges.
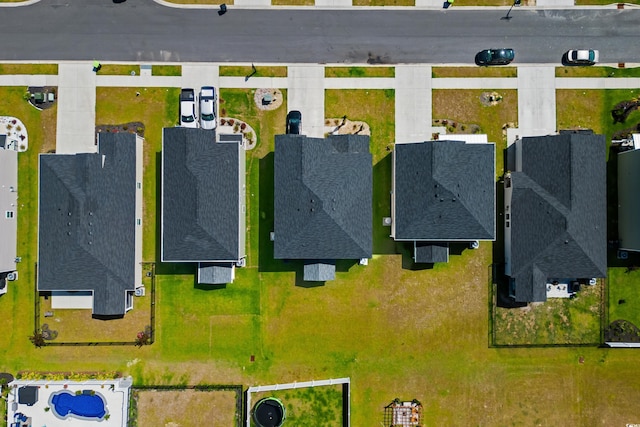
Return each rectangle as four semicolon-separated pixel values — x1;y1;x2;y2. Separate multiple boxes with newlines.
49;390;107;421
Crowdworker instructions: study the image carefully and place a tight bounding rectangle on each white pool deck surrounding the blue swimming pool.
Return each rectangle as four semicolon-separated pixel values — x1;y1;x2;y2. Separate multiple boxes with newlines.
7;378;132;427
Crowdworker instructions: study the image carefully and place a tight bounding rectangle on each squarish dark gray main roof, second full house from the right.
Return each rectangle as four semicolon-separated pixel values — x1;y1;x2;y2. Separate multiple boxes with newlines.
394;141;496;240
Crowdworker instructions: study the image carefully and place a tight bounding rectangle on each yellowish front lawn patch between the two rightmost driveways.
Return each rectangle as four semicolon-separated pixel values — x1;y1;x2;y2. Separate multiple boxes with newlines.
433;89;518;176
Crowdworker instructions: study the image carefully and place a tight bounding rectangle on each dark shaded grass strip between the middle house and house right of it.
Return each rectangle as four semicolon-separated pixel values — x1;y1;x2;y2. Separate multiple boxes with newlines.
373;154;397;255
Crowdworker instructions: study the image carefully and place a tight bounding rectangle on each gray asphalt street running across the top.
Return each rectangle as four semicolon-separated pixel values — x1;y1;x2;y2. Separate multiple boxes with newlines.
0;0;640;65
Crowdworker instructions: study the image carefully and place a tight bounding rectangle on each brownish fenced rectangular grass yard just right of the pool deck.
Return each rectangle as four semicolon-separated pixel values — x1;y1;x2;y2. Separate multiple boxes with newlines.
133;389;241;427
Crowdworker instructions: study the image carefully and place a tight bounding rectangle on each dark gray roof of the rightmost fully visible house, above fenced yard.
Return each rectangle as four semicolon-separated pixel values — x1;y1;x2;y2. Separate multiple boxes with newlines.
510;134;607;302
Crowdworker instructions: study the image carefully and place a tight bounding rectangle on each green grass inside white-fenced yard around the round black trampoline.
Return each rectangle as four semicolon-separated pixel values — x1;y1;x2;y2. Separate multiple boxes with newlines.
248;385;342;427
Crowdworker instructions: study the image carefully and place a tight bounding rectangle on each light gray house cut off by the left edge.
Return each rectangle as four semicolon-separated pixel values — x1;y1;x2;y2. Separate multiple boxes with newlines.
0;143;18;295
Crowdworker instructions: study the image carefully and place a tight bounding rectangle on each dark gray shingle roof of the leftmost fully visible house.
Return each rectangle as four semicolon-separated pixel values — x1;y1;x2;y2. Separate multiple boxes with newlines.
38;133;136;316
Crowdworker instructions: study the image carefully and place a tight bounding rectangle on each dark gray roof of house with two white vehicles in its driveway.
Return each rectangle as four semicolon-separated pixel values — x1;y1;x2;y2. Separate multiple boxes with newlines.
162;127;245;262
